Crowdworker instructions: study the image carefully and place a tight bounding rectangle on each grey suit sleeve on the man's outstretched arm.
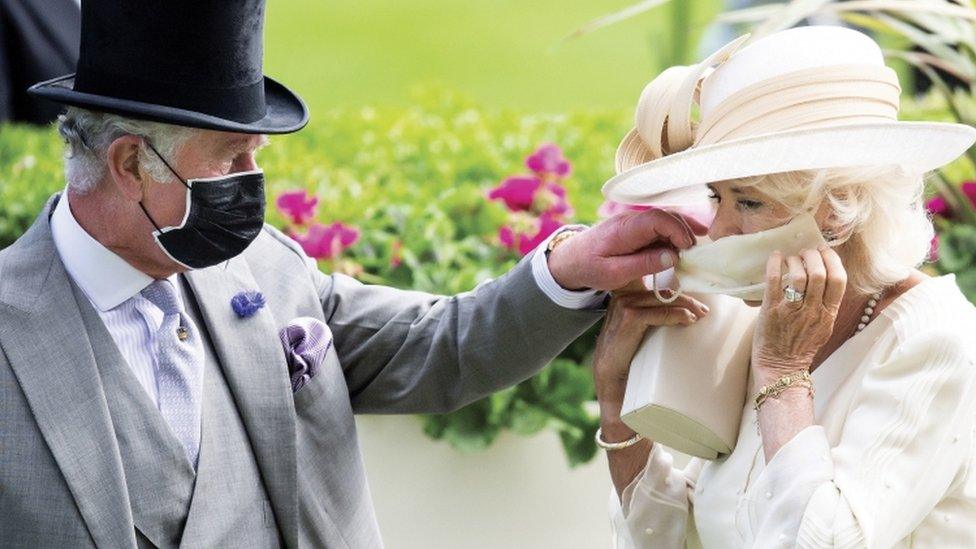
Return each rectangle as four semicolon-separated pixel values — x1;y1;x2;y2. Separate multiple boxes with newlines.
308;246;605;413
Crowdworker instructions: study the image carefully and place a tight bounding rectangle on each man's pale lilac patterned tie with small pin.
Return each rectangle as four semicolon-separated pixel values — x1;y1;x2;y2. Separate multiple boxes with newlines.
142;280;203;468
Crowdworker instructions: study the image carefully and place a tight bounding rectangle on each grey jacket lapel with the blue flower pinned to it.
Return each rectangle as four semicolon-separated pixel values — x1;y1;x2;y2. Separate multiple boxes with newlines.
185;257;298;547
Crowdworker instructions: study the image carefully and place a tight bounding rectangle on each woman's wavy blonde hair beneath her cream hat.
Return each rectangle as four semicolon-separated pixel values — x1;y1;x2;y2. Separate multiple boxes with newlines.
738;166;934;294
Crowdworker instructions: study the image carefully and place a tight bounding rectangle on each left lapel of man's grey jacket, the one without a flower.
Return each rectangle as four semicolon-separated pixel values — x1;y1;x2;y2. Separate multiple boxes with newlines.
0;198;136;547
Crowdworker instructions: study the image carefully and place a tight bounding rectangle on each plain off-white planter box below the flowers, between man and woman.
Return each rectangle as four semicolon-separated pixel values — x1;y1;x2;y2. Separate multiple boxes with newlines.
357;416;611;549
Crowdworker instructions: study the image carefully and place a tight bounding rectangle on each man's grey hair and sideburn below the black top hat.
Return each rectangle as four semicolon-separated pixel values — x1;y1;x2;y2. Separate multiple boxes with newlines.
58;107;200;194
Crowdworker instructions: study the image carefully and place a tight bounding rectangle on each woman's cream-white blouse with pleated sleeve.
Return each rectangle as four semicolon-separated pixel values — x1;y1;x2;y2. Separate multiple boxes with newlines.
610;275;976;549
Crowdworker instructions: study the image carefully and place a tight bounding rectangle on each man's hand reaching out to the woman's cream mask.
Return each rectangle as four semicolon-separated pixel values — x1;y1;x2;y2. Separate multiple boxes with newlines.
549;209;708;290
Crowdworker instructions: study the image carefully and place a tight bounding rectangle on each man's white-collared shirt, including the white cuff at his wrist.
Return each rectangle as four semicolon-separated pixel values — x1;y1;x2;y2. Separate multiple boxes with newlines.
51;190;606;406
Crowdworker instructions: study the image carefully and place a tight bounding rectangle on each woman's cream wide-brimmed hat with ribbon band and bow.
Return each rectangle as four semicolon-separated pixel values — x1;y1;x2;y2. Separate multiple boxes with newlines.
603;26;976;205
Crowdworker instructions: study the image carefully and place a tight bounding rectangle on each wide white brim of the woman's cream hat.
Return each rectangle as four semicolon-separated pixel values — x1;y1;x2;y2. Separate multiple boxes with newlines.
603;122;976;204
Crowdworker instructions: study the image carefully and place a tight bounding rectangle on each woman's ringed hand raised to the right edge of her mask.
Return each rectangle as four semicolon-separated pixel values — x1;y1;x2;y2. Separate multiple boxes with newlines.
752;246;847;383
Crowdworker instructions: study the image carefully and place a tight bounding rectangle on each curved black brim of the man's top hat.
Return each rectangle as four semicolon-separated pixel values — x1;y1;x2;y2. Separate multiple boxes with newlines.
27;74;308;134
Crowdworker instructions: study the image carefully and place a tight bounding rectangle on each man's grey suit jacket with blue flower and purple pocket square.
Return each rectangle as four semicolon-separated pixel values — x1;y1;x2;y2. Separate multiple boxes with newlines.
0;195;603;549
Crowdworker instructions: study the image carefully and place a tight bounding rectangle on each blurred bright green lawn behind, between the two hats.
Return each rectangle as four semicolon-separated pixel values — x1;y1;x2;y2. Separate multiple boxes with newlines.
265;0;718;115
